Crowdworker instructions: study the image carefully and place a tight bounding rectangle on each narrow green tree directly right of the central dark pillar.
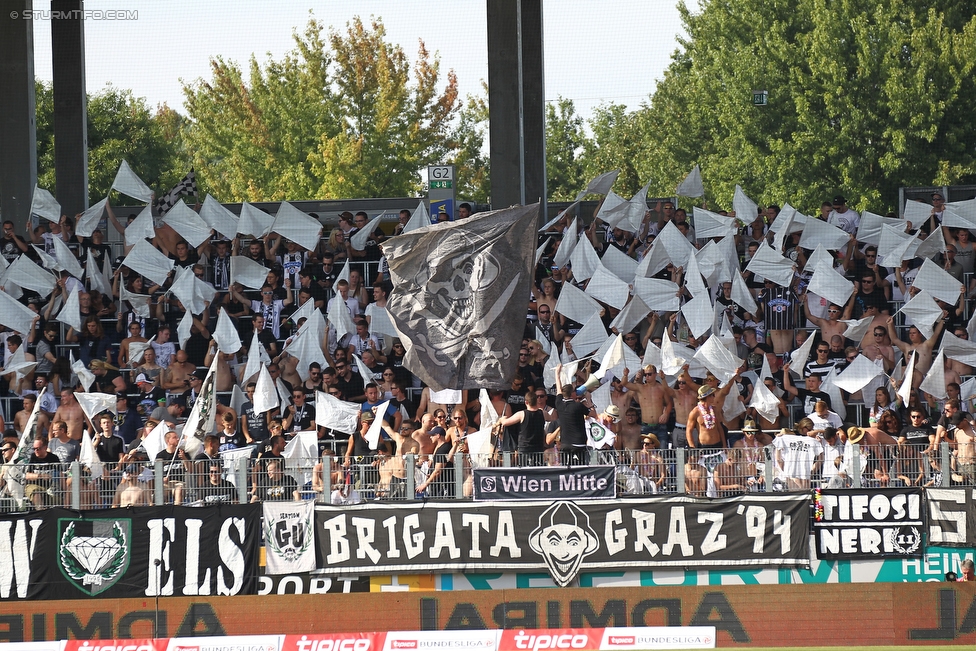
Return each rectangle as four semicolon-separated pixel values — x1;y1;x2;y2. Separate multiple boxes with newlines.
546;97;586;201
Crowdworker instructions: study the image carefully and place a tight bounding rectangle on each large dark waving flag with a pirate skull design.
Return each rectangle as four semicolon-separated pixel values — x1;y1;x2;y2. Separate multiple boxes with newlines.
383;203;539;390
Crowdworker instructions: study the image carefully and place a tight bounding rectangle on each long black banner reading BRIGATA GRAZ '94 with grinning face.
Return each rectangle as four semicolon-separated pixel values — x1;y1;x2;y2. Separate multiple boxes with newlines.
315;495;810;586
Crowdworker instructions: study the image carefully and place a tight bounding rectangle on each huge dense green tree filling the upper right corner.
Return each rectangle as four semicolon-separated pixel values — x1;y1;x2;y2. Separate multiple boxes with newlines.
633;0;976;212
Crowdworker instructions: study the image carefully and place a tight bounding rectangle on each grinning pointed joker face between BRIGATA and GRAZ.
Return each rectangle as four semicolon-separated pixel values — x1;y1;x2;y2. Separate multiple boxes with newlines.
529;502;600;588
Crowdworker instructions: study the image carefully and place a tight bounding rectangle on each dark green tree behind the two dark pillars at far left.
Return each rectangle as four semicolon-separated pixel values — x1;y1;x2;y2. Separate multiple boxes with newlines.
34;82;181;203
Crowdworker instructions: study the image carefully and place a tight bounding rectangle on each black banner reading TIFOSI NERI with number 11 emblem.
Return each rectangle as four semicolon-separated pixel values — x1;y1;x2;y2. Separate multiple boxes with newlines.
813;488;925;559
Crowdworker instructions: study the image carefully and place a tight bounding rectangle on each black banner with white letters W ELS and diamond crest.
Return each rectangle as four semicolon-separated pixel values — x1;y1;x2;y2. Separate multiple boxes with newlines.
0;504;261;599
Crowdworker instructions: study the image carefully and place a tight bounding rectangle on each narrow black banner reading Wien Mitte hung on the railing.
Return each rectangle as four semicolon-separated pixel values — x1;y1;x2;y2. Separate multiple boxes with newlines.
474;466;617;500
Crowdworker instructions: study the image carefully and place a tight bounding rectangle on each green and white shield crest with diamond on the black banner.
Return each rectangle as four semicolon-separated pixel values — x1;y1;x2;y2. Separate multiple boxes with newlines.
58;518;132;596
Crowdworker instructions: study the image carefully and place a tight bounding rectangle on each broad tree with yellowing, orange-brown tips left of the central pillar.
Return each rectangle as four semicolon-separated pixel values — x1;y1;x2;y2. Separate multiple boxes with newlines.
184;18;458;201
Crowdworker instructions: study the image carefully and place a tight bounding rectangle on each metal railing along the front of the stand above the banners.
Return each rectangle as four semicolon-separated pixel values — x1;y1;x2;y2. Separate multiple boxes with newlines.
0;442;964;512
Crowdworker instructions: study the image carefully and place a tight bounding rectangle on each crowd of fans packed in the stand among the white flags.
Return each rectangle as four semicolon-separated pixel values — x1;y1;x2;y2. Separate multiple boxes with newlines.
0;188;976;508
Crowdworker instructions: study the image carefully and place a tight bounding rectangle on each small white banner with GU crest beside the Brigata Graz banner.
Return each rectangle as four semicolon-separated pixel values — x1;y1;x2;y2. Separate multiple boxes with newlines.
264;501;315;574
